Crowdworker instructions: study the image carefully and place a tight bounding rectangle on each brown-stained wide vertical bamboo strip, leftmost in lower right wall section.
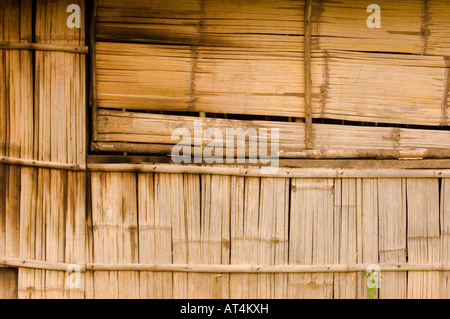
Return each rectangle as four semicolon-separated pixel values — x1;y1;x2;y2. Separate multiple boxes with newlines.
92;173;139;299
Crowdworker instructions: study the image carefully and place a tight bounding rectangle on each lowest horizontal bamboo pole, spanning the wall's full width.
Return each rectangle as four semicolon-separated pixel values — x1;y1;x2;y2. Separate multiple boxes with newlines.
0;257;450;274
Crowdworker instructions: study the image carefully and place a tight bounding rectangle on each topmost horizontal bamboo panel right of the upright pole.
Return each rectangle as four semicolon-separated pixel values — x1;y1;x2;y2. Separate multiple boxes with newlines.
312;0;450;56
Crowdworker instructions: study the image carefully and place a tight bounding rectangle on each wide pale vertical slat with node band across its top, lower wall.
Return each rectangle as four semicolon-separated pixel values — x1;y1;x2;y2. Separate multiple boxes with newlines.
288;179;335;299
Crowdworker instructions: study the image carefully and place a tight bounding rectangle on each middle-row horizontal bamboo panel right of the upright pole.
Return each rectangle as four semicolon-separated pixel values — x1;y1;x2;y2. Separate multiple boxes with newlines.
312;51;449;126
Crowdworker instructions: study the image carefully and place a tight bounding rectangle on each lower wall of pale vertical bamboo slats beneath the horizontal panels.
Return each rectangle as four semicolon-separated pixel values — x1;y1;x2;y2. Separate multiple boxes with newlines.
85;172;447;299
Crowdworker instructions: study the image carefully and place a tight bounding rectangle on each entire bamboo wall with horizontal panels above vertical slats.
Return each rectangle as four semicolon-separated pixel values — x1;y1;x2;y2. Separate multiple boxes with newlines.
0;0;450;298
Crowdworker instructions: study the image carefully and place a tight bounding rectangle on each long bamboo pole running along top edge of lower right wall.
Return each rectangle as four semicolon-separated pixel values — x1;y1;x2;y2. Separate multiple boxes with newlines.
88;163;450;178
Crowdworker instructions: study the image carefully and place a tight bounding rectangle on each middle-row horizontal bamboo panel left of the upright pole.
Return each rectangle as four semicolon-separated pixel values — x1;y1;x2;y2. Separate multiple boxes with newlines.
97;42;306;117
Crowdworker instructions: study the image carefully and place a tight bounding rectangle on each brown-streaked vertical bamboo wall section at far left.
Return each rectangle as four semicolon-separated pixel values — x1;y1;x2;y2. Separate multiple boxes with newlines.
0;0;87;298
